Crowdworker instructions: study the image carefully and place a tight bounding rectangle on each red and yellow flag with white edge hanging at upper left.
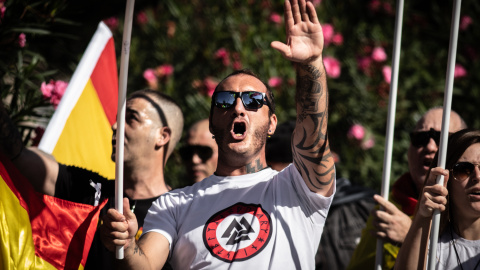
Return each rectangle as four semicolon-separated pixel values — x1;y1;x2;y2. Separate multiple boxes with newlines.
38;22;118;179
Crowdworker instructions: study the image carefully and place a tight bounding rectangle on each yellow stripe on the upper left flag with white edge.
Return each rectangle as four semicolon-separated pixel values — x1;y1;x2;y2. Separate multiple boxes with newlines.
52;80;115;179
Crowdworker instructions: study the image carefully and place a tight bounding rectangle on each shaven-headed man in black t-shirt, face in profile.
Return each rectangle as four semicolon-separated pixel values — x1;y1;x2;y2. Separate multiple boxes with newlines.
0;89;183;269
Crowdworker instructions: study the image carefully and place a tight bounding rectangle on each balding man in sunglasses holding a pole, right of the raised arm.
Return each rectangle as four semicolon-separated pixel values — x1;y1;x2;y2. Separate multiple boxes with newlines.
347;107;467;269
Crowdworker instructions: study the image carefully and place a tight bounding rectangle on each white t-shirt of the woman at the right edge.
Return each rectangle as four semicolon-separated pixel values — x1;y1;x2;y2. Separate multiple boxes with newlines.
435;227;480;270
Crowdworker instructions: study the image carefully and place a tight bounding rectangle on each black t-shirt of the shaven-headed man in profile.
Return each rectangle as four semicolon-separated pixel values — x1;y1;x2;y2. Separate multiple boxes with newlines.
55;164;171;270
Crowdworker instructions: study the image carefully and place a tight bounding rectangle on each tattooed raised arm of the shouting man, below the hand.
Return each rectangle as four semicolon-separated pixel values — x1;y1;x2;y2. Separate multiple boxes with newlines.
292;65;335;189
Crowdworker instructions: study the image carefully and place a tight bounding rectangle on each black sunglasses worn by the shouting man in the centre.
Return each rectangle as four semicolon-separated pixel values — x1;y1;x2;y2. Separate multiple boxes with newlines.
212;91;273;111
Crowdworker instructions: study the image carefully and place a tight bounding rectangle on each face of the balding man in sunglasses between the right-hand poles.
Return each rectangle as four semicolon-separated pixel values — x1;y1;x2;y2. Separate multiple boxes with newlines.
408;109;461;191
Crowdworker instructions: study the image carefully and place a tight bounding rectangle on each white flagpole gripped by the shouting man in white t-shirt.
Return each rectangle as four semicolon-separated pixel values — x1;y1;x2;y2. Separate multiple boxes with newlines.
115;0;135;259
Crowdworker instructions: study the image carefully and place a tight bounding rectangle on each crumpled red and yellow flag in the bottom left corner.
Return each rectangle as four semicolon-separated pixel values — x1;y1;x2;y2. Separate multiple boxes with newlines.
0;156;107;269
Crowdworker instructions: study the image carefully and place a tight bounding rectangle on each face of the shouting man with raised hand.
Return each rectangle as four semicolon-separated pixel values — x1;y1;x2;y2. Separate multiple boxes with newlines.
210;74;277;161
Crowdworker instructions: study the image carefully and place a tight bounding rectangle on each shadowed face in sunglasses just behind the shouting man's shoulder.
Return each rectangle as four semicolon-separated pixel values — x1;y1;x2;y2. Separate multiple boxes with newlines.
185;120;218;182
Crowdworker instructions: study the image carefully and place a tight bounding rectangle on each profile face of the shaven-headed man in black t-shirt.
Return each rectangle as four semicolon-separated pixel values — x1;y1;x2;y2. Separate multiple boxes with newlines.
112;97;160;163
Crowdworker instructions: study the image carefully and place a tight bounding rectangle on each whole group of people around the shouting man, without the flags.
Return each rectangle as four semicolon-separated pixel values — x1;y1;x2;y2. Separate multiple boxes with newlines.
0;0;480;269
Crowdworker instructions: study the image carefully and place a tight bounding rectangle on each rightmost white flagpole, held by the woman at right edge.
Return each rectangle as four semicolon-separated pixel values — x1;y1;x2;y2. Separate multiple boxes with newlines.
428;0;462;270
